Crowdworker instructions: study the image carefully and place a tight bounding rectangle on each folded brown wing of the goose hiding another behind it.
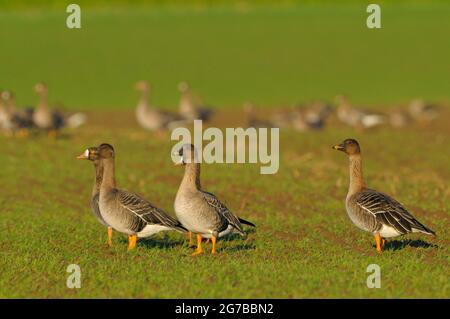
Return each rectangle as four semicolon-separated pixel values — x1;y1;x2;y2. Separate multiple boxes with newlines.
117;191;186;231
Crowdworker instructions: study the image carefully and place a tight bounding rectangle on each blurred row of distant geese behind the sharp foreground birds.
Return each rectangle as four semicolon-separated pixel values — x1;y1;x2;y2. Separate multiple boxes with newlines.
0;81;439;136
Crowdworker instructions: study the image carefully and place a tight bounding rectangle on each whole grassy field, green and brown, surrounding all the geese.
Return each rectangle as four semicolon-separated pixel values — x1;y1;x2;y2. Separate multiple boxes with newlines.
0;2;450;298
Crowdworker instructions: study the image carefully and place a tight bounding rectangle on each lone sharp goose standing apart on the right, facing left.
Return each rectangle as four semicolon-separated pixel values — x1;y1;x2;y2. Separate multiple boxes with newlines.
333;139;435;253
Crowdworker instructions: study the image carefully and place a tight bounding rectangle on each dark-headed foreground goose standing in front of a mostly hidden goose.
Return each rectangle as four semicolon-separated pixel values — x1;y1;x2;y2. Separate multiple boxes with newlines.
98;144;187;249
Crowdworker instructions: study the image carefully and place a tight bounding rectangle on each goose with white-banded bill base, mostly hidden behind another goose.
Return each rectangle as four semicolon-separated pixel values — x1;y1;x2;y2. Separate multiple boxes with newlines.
77;147;112;247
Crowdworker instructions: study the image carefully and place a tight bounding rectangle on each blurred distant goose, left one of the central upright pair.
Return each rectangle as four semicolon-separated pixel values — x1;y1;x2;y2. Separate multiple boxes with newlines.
135;81;183;132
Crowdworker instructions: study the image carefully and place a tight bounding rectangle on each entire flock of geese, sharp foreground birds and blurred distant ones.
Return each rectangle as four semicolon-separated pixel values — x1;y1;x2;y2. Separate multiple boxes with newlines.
0;81;439;255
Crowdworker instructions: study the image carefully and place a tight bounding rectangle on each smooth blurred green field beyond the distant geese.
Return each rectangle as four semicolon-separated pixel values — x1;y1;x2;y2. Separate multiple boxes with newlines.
0;0;450;109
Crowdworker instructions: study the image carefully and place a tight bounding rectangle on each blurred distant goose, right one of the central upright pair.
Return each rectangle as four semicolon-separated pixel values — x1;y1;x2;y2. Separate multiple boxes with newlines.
178;82;213;122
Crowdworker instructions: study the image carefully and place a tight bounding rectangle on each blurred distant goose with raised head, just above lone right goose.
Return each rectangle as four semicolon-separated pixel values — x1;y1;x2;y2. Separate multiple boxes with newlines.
335;95;386;129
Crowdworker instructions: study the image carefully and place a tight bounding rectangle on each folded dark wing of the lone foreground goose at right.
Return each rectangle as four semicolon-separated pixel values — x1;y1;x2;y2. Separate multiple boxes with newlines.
356;190;434;234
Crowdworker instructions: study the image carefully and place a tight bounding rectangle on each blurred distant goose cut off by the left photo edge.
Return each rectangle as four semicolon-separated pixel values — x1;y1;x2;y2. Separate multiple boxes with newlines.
0;91;33;136
